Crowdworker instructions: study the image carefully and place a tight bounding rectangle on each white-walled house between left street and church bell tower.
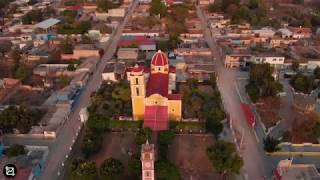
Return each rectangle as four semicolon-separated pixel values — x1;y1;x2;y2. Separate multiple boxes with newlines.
101;62;126;82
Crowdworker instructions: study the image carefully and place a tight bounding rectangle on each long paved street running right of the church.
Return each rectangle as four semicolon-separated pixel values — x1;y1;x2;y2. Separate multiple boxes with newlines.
197;7;271;180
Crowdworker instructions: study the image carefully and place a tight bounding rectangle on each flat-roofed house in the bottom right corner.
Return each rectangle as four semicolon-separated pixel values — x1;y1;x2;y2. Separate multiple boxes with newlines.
273;159;320;180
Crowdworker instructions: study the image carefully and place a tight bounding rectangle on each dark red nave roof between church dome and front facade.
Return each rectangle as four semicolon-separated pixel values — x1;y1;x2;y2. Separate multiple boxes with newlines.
147;73;169;97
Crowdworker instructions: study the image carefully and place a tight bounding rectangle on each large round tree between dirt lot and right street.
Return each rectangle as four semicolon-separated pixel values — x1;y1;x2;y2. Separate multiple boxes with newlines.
207;140;243;177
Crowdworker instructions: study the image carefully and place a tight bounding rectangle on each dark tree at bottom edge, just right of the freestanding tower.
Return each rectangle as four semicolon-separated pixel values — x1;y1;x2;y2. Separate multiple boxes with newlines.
155;160;181;180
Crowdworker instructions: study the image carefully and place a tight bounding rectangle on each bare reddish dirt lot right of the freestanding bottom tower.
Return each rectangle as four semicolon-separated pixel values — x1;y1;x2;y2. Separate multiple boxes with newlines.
169;135;219;180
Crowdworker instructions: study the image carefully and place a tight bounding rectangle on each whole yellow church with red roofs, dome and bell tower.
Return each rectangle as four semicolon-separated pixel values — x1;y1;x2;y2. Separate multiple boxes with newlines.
127;50;181;131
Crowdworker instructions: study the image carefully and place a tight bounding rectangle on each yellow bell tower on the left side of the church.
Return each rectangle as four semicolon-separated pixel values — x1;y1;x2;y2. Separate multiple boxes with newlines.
129;65;146;120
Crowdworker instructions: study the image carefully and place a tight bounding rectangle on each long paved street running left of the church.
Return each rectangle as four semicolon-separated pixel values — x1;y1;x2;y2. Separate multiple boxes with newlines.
41;1;138;180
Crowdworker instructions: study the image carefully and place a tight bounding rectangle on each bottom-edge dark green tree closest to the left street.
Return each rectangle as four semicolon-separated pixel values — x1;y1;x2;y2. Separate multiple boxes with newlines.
70;159;98;180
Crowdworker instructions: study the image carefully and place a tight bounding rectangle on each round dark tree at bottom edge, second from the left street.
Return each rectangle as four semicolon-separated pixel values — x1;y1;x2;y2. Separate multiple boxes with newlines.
100;158;124;180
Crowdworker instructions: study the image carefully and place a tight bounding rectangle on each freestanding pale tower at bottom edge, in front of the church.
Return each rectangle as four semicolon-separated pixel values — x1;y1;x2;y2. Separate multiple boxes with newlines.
141;140;155;180
